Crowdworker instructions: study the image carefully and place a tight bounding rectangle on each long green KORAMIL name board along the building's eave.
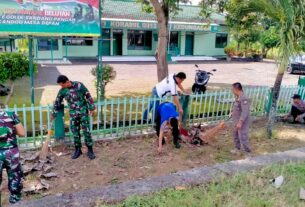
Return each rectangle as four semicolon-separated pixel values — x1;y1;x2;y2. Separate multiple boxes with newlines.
102;20;218;32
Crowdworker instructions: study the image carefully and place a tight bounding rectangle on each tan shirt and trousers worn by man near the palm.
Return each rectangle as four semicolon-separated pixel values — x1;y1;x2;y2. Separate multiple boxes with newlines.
232;93;251;152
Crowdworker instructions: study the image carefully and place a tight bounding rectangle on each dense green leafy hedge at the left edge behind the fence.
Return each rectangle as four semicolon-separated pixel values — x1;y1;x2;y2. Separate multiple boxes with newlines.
0;53;37;83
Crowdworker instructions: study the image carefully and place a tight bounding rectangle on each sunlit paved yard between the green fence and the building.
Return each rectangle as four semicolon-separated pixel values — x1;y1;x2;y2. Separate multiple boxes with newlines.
36;61;298;104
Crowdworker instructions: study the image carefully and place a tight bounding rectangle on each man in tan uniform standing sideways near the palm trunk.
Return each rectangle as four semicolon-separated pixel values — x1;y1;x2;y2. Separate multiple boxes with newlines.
231;83;251;155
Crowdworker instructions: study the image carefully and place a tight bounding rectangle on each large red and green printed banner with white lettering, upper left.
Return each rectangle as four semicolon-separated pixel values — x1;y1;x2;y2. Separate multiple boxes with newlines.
0;0;100;36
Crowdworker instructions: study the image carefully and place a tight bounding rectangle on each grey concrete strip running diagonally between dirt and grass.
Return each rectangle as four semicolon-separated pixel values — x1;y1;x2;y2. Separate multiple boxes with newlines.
13;147;305;207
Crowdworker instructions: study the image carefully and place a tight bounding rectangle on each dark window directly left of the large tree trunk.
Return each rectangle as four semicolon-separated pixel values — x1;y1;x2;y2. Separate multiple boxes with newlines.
128;30;152;50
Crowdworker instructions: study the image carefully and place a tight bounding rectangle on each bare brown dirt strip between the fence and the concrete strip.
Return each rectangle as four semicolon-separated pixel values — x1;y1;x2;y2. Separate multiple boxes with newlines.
2;119;305;205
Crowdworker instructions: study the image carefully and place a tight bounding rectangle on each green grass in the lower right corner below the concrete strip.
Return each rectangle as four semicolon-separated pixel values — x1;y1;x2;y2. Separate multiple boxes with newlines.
97;162;305;207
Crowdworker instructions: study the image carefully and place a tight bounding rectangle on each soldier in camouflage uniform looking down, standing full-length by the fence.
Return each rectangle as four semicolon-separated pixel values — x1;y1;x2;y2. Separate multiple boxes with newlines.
53;75;95;159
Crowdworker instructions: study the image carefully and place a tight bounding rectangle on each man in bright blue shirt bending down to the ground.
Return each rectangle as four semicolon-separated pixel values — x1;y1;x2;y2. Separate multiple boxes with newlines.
156;102;180;153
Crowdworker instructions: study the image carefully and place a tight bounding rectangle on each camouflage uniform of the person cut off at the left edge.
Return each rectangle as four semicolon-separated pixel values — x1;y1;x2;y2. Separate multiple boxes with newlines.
0;109;23;203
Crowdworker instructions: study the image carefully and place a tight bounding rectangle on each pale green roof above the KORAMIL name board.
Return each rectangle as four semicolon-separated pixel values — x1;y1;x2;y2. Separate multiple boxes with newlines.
103;0;225;25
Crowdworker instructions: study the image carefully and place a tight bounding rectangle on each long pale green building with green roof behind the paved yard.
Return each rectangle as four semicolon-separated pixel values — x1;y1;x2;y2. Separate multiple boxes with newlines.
34;0;228;59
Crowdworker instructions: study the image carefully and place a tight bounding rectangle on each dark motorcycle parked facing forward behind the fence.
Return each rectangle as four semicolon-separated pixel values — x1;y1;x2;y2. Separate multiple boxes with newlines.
192;65;216;94
